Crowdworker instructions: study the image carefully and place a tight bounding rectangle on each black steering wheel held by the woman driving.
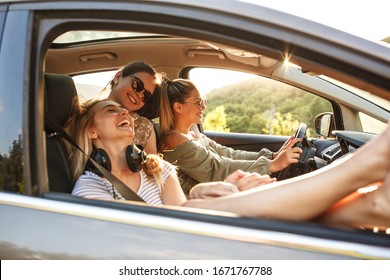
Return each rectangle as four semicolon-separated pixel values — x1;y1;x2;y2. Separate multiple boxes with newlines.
278;123;315;181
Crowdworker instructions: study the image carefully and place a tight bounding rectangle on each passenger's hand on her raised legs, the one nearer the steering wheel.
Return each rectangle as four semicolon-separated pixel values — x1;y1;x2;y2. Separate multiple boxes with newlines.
225;170;276;192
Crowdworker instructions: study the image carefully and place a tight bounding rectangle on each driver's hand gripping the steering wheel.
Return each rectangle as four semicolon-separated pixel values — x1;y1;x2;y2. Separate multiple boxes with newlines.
269;137;302;173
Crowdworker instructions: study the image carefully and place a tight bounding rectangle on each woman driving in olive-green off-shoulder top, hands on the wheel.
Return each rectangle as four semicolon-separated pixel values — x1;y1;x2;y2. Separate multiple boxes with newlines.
159;79;302;194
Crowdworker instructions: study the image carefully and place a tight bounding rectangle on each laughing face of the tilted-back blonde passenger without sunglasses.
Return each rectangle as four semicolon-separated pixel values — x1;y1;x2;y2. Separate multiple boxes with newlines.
88;100;134;148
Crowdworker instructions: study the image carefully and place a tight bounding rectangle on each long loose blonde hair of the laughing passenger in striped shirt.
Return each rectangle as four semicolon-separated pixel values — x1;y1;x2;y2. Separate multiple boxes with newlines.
64;99;164;191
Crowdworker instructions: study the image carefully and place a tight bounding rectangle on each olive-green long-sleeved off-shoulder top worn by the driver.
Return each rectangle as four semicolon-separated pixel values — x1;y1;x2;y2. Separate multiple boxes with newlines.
161;135;272;194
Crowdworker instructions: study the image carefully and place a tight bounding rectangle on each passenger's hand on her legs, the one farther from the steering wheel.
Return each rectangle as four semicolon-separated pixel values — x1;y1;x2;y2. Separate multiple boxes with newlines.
189;182;239;199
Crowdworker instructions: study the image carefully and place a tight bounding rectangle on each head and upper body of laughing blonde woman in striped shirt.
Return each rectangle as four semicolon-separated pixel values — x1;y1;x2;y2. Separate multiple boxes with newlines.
65;99;186;205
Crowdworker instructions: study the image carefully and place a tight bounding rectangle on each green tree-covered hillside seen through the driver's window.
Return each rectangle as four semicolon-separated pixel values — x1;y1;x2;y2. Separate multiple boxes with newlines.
205;77;332;135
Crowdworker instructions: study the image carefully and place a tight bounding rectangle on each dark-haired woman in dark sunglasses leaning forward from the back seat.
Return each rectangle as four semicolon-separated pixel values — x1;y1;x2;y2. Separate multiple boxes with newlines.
108;61;157;154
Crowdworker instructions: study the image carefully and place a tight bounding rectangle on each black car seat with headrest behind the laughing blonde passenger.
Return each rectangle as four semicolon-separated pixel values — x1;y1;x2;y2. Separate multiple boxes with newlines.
44;73;77;193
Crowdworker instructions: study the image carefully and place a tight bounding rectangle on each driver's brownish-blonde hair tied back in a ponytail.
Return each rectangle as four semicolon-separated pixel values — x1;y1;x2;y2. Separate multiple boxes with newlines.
160;78;196;137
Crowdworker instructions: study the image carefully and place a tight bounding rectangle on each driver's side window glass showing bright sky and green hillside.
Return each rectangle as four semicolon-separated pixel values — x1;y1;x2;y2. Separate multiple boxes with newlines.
189;68;333;136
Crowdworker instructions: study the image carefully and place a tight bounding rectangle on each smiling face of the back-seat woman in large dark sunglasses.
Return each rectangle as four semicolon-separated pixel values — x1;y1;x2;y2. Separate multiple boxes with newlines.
109;71;156;112
